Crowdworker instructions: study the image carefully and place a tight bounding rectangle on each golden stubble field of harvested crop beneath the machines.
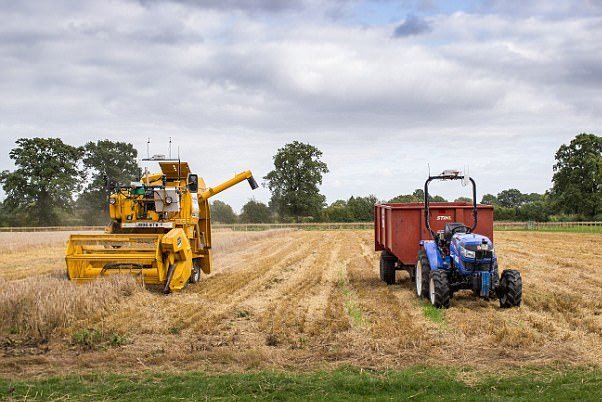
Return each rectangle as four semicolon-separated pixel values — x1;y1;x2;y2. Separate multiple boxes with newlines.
0;231;602;376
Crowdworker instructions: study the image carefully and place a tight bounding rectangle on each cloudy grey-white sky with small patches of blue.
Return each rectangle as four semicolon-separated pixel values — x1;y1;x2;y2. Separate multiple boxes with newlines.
0;0;602;209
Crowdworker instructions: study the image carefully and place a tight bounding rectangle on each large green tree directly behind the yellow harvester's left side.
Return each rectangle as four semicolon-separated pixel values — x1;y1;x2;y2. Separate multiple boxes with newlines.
78;140;140;224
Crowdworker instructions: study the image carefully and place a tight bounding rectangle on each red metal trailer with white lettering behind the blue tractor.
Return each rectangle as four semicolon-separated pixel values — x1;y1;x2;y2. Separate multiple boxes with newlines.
374;202;493;269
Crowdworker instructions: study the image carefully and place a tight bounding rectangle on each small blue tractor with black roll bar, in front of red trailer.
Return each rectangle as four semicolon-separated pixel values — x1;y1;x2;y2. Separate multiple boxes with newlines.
412;171;523;308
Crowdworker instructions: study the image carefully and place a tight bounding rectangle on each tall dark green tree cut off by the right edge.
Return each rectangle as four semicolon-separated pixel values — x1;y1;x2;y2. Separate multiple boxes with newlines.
550;133;602;218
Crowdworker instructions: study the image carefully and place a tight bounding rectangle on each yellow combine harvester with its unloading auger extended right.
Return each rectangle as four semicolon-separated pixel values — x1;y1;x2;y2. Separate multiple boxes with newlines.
65;160;257;293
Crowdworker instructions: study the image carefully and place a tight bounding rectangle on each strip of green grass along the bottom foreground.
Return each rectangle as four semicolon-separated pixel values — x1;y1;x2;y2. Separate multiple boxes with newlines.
0;367;602;401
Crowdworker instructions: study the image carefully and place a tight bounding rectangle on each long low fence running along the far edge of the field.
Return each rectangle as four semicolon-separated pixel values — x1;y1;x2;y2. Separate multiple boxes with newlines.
0;221;602;232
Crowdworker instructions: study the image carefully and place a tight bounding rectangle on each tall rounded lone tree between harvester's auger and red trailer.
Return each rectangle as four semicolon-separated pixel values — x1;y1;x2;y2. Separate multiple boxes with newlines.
264;141;328;221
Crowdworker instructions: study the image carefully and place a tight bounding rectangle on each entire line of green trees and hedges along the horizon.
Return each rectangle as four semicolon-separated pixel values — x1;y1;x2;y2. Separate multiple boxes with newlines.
0;133;602;226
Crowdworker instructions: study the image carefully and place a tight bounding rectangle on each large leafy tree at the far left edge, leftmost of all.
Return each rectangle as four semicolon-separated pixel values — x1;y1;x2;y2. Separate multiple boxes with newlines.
0;138;82;225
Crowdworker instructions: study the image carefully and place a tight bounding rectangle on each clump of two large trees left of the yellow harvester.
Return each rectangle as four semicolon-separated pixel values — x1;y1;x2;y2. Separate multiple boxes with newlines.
0;138;141;226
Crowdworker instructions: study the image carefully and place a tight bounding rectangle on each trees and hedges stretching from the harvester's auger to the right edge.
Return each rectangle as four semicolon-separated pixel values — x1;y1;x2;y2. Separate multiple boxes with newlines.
212;133;602;223
